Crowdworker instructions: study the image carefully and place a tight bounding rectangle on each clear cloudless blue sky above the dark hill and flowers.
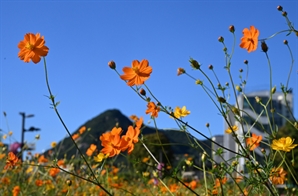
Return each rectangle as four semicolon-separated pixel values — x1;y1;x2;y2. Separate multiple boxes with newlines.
0;0;298;155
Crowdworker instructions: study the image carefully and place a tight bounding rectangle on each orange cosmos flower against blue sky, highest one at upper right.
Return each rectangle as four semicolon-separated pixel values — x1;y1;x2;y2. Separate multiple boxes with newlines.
240;26;260;52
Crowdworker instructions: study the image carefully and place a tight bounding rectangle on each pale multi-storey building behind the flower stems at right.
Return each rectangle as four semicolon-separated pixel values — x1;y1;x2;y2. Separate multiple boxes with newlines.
223;91;293;172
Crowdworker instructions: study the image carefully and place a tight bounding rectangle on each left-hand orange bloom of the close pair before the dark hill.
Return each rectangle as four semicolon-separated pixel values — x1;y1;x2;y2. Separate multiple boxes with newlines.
99;127;122;157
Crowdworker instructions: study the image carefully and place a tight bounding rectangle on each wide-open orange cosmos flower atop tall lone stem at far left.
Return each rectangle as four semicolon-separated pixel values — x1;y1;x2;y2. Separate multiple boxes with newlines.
18;33;49;64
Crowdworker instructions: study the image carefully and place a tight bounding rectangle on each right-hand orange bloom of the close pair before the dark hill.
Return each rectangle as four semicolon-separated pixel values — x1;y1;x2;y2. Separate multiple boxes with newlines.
121;126;140;154
